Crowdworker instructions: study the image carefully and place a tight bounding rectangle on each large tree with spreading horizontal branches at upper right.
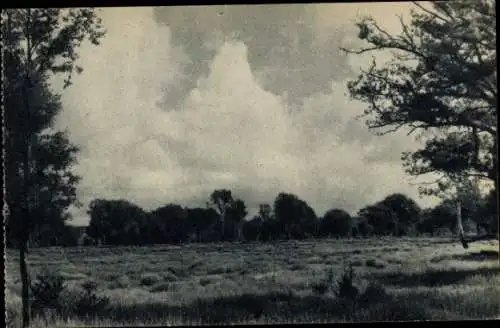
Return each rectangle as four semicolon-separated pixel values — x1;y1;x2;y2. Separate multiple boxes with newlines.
344;0;498;199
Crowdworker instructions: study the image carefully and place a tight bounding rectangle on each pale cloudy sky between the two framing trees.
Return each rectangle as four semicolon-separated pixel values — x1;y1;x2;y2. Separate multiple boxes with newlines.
53;2;442;225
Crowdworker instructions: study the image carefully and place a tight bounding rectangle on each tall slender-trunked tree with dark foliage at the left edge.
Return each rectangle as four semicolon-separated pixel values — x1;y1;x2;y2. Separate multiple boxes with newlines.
2;8;104;327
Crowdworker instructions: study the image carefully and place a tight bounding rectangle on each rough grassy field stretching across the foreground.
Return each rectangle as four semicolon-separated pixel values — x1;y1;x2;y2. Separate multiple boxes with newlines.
6;238;500;327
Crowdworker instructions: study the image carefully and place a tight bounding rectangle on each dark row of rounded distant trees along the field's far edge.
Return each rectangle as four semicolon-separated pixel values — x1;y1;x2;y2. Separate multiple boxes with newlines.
14;189;498;246
